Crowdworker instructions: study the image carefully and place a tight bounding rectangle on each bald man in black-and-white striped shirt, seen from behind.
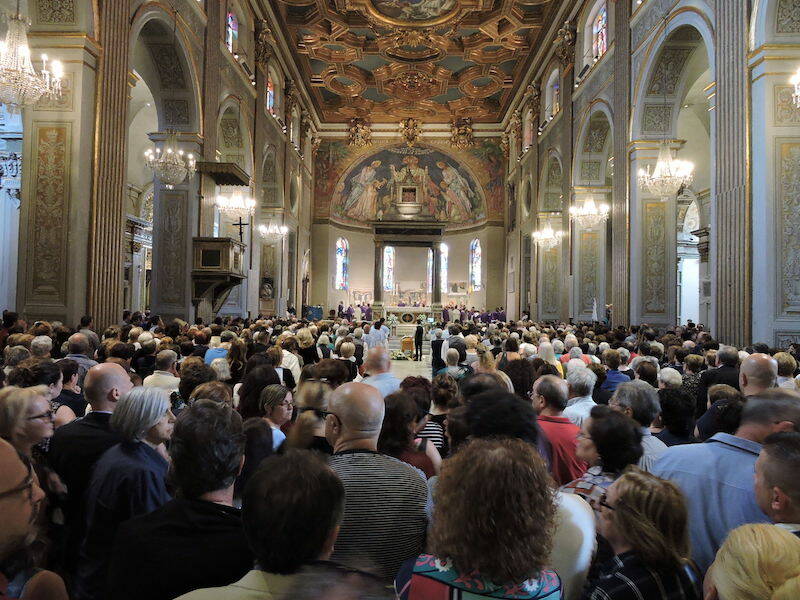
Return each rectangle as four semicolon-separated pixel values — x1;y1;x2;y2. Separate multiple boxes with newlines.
325;383;428;582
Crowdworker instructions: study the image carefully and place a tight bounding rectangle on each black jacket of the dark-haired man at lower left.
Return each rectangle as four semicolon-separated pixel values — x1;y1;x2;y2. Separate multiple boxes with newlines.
108;498;253;600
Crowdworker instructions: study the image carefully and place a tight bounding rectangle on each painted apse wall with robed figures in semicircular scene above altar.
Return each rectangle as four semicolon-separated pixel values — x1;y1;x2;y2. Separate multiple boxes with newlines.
315;140;504;227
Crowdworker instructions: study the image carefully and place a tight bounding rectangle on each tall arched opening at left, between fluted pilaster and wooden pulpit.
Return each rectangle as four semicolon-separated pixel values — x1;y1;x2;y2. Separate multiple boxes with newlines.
129;4;202;320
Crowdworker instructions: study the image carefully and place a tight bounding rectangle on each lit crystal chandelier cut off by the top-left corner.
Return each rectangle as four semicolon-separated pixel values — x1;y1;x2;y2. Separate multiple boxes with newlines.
0;0;64;113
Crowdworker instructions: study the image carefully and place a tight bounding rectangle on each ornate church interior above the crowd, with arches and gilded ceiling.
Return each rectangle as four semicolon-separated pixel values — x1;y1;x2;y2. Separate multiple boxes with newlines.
0;0;800;346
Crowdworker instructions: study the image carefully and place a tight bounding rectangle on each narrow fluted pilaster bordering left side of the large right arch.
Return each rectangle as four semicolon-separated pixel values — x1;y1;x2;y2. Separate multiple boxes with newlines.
612;2;631;325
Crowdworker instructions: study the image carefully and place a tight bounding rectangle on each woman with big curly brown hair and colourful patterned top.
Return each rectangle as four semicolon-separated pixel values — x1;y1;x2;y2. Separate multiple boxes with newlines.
395;439;562;600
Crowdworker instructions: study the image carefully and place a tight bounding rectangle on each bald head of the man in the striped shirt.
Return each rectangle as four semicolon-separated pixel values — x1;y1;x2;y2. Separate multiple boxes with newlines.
330;383;385;440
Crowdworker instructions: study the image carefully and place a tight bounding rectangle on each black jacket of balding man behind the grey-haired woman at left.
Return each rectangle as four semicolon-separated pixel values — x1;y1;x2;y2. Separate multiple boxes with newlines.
47;412;122;571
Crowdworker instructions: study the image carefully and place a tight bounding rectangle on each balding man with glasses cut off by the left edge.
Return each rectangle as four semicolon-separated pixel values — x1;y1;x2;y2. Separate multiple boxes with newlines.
0;440;67;600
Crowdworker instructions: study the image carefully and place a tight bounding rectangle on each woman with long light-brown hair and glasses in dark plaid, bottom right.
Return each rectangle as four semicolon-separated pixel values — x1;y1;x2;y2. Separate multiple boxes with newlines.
584;466;700;600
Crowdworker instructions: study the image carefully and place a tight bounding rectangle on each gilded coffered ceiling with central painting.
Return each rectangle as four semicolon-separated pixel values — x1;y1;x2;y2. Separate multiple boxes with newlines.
272;0;557;123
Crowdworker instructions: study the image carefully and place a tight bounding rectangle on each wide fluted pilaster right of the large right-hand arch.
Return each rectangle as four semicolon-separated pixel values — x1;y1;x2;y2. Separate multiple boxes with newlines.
711;0;752;346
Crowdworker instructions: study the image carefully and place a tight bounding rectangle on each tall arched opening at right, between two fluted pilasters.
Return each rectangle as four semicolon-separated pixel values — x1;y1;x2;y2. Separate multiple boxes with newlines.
630;19;716;326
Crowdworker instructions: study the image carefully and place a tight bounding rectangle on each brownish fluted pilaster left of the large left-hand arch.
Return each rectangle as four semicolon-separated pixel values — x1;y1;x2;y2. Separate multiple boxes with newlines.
87;0;130;329
